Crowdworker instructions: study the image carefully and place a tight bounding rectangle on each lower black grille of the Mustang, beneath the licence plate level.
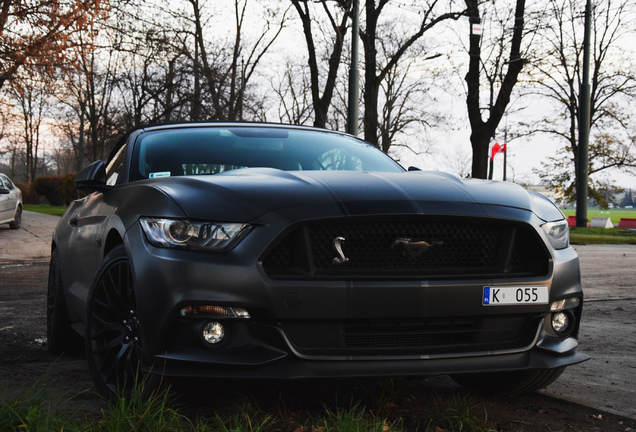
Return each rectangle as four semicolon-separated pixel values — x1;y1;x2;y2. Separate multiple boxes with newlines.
283;314;543;356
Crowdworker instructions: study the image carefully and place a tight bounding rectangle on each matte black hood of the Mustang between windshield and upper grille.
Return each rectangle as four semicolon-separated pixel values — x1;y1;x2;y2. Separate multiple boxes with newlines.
148;168;563;221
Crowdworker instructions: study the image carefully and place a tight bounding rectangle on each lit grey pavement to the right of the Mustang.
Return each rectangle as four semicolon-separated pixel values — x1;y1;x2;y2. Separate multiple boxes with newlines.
543;245;636;419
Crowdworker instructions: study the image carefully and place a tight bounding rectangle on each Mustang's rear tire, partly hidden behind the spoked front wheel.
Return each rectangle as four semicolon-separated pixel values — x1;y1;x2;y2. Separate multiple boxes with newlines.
46;250;84;355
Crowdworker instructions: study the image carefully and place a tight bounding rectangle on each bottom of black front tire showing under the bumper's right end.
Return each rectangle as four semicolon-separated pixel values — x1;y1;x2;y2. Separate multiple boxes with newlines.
451;366;565;396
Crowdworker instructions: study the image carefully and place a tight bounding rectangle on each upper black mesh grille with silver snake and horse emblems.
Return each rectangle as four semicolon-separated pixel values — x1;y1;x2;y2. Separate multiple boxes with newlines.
262;217;549;279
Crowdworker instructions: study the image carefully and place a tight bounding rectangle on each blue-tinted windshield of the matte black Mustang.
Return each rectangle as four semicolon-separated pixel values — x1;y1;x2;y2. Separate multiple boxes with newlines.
132;126;403;180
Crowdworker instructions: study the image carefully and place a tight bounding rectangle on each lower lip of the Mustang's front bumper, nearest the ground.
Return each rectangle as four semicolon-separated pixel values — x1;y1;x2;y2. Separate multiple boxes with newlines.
149;326;589;379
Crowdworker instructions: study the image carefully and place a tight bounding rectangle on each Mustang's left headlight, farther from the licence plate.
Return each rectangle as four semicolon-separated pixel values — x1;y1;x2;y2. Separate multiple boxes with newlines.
141;218;252;252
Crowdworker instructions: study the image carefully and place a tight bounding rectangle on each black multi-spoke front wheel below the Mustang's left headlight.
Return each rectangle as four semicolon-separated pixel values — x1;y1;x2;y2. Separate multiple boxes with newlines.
85;245;160;399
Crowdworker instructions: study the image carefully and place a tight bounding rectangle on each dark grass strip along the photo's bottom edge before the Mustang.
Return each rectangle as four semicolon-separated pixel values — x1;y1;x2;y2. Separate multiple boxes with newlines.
0;379;496;432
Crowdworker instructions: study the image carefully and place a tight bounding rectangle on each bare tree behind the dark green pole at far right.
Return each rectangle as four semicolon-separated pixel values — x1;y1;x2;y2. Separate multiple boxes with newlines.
529;0;636;205
